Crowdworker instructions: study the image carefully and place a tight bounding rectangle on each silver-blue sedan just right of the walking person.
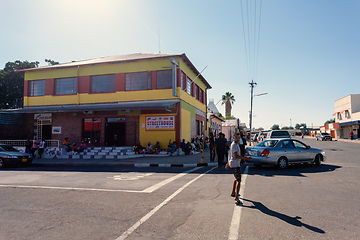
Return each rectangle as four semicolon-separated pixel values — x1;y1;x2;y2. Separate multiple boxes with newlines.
246;138;326;169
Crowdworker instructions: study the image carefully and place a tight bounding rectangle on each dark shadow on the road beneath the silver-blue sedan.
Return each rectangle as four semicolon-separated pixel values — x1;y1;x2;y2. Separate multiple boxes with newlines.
249;164;341;177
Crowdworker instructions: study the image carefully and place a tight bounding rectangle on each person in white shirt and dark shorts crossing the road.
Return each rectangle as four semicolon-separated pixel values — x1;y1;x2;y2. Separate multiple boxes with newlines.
225;133;252;205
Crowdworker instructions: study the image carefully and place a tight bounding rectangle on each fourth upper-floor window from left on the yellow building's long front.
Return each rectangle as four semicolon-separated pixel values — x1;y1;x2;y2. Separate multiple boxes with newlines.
126;71;151;91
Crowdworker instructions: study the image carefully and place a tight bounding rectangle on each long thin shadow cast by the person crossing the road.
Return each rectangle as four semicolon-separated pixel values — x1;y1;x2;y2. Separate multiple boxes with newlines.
242;198;325;234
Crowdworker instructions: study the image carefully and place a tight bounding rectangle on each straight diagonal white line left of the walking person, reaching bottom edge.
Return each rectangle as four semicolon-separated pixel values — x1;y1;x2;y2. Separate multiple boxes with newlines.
116;167;217;240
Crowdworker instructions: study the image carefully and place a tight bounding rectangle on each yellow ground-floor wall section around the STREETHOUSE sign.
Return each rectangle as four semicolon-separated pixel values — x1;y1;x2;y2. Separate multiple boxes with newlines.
139;114;176;149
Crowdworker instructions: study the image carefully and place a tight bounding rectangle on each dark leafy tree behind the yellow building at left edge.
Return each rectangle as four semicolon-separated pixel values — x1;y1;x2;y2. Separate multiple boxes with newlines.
0;60;39;109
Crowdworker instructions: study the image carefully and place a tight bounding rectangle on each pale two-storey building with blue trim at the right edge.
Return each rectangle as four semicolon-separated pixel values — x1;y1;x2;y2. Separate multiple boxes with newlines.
333;94;360;139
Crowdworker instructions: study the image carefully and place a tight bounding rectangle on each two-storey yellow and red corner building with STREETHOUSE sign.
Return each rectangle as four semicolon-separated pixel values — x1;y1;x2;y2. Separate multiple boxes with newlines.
19;54;211;148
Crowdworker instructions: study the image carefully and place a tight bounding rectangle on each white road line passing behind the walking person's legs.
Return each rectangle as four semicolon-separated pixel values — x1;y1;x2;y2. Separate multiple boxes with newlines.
229;166;249;240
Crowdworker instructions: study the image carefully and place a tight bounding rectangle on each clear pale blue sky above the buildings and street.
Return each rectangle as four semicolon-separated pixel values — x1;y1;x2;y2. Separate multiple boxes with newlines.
0;0;360;129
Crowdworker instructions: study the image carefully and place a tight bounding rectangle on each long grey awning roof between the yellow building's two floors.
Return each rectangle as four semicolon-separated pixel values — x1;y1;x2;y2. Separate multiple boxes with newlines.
0;99;180;113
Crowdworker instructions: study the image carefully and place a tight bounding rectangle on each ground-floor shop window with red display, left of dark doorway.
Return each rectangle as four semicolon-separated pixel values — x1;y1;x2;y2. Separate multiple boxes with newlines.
82;118;101;145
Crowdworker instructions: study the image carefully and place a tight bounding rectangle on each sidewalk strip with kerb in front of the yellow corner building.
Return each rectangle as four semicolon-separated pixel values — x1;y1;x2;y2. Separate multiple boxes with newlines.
33;148;217;167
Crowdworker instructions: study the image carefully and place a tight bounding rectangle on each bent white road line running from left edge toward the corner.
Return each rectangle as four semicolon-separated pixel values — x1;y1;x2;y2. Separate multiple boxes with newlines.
0;167;203;193
